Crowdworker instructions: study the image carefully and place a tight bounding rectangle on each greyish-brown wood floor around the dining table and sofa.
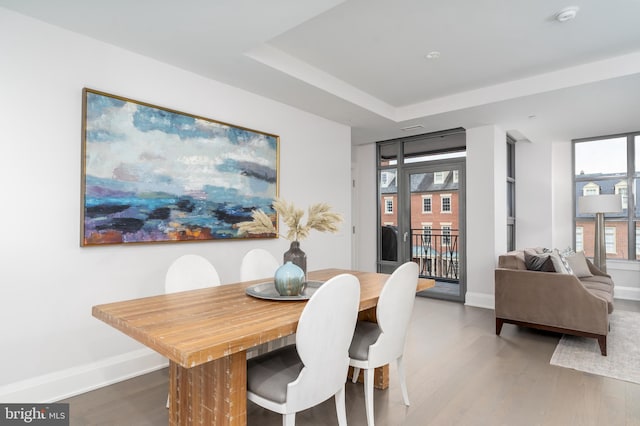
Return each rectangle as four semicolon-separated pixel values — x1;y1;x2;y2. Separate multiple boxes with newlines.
61;297;640;426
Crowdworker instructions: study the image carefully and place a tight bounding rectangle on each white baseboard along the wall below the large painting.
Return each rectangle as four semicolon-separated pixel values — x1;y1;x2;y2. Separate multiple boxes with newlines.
0;348;169;403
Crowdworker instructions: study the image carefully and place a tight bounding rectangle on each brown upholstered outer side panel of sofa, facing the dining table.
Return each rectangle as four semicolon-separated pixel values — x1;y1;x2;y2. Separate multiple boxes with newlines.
495;268;609;335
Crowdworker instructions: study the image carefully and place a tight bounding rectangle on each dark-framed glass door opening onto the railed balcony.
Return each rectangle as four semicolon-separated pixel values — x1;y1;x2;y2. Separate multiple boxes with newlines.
400;158;466;302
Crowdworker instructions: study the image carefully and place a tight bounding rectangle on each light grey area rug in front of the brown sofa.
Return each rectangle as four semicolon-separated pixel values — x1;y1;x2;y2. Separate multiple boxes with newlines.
551;311;640;384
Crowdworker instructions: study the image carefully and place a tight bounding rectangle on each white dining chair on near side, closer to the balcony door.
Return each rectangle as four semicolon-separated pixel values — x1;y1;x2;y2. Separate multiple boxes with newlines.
349;262;418;426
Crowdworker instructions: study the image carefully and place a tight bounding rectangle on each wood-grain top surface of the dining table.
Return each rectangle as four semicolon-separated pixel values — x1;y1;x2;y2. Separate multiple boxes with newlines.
92;269;434;368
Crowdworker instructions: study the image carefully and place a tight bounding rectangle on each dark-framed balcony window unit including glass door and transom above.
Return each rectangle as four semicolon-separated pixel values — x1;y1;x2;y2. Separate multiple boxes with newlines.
377;129;466;301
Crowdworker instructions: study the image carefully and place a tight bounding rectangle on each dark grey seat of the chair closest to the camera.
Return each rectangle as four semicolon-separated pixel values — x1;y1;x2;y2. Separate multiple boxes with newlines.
247;345;304;403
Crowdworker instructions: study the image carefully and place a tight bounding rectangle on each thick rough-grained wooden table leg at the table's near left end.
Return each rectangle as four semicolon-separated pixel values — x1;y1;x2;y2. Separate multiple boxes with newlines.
169;351;247;426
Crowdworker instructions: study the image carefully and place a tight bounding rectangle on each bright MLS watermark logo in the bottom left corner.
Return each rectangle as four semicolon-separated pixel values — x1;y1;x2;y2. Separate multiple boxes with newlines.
0;404;69;426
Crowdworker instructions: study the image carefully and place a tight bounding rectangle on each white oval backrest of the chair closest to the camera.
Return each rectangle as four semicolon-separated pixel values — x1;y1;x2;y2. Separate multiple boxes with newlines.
287;274;360;411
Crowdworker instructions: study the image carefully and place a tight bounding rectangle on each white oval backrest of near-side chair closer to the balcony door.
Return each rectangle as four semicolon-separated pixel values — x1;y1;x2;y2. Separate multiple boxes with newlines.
369;262;419;365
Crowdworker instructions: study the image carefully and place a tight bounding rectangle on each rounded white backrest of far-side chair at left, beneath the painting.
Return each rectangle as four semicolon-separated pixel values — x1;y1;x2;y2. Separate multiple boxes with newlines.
164;254;220;293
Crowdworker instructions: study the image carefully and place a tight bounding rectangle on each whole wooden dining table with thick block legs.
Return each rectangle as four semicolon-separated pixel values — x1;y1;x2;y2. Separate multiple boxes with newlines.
92;269;434;425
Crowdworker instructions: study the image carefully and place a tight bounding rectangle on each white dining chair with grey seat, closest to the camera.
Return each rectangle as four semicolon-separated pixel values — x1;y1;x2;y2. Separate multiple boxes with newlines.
247;274;360;426
